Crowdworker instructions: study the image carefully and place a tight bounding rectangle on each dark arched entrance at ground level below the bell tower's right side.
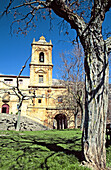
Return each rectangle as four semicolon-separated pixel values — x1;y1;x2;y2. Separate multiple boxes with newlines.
54;114;67;129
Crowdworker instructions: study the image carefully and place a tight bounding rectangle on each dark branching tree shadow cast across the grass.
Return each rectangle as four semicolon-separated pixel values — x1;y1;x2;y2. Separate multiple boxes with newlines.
0;134;83;170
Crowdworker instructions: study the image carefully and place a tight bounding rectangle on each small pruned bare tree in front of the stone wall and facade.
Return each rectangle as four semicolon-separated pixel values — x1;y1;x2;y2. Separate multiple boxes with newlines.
0;50;45;131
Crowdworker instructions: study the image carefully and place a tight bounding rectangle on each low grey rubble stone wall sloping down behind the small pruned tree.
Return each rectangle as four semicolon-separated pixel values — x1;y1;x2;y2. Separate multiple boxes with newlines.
0;113;48;131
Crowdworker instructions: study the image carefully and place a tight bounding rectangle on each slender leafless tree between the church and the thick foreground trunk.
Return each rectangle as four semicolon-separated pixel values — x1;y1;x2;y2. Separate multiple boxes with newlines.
58;45;84;129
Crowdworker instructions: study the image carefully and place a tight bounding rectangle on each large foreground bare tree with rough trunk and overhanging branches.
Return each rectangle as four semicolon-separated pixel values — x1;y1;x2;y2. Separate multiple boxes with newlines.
3;0;111;169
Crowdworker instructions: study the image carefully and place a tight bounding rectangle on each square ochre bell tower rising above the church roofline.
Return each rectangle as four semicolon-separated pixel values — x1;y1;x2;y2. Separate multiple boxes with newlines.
29;36;53;87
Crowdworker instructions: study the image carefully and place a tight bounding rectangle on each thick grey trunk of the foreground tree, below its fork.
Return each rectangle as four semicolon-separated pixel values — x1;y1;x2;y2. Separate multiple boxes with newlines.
82;33;109;170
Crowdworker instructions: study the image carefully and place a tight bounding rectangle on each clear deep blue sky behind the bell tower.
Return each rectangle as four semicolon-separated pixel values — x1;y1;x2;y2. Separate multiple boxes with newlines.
0;1;111;78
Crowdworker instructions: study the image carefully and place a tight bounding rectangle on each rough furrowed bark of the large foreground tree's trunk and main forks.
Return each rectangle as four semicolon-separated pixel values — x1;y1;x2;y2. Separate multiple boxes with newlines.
49;0;111;170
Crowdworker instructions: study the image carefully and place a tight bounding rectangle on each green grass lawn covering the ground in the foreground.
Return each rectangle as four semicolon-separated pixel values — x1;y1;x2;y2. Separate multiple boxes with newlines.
0;130;111;170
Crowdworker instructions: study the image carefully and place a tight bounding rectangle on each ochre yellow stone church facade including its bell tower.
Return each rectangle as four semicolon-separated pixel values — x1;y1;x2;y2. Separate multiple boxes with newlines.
0;36;74;129
